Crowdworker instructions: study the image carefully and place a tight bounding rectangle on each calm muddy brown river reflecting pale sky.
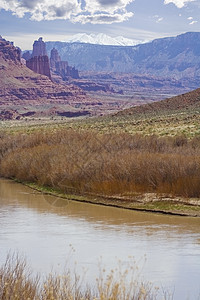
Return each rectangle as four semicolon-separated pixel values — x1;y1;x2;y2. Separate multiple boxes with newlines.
0;179;200;300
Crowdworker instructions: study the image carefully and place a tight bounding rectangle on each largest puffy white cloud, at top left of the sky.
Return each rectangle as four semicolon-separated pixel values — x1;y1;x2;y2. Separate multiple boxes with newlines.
0;0;134;24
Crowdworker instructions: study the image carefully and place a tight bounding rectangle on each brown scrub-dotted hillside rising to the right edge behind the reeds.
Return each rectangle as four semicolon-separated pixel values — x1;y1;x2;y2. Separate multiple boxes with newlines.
74;88;200;138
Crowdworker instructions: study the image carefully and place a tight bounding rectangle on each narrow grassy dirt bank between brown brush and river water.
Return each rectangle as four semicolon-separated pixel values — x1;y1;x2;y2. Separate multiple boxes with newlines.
15;180;200;217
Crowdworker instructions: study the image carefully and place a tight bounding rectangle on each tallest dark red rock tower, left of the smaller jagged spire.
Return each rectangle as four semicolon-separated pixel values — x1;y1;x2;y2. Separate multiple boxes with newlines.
23;38;51;79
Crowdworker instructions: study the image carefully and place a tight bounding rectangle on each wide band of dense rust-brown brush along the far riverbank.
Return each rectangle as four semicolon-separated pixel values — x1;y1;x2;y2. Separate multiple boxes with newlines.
0;129;200;197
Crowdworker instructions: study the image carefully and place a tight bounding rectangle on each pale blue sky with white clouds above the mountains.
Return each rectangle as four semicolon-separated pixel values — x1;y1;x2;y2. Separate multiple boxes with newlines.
0;0;200;50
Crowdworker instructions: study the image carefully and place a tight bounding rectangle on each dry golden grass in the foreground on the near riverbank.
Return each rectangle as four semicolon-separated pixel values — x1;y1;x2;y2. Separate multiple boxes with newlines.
0;255;166;300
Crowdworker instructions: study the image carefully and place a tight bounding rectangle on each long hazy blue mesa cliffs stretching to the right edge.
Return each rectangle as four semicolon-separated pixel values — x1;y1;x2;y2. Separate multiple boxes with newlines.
46;32;200;84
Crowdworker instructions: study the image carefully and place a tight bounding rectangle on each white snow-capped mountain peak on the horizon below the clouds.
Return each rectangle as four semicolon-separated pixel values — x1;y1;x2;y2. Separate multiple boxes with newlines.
66;33;147;46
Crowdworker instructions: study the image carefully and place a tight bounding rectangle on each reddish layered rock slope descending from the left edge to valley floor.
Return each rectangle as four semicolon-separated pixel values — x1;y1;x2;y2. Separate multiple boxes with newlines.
0;38;103;120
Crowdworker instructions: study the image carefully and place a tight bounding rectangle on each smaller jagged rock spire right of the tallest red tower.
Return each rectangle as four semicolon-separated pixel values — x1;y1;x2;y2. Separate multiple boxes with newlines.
50;48;79;81
